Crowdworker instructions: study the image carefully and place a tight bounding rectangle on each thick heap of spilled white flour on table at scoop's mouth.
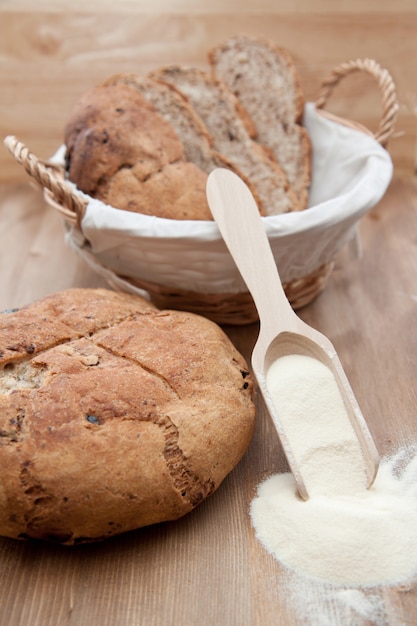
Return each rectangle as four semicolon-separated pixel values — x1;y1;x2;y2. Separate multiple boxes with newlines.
251;450;417;587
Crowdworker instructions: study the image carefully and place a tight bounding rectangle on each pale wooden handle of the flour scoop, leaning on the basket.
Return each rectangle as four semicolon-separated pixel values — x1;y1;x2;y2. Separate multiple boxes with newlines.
206;168;297;341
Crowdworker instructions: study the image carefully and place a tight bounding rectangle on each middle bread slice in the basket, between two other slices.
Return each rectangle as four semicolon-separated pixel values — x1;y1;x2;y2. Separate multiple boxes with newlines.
150;65;299;215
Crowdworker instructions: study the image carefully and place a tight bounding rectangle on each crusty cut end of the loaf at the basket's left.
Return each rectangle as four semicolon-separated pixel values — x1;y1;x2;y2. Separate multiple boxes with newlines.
65;83;212;220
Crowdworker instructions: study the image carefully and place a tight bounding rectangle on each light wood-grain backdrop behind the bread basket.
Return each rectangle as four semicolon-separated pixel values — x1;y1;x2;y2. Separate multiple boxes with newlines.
0;0;417;183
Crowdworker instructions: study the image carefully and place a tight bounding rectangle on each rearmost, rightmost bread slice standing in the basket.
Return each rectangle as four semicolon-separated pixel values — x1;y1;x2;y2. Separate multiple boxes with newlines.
209;36;311;208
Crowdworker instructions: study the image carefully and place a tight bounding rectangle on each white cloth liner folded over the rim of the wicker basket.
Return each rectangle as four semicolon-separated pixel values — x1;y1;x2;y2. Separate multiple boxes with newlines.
66;103;393;293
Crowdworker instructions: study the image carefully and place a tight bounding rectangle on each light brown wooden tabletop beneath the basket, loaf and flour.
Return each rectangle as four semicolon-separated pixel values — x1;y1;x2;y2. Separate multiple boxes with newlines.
0;173;417;626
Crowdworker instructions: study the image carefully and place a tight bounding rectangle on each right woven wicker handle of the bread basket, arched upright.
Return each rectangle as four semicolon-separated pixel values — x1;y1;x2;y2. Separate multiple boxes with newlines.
315;59;398;147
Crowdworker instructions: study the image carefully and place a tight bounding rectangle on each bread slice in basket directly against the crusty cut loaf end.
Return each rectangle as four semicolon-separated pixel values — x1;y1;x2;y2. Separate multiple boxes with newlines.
103;73;265;215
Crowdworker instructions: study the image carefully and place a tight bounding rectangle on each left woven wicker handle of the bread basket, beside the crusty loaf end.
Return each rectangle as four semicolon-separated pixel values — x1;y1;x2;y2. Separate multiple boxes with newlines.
4;135;87;225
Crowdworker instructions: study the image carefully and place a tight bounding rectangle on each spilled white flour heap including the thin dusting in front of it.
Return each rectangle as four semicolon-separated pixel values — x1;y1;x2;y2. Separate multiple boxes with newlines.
250;446;417;626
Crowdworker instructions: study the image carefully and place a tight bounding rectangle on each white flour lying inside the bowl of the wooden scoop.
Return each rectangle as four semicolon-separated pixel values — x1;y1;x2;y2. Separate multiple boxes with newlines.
266;354;367;496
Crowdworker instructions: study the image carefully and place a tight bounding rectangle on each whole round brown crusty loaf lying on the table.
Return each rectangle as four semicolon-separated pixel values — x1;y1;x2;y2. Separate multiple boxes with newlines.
0;289;254;545
